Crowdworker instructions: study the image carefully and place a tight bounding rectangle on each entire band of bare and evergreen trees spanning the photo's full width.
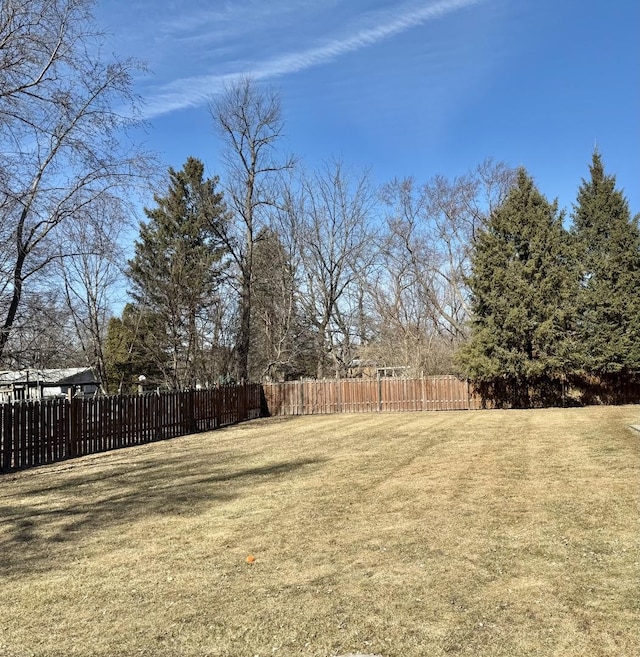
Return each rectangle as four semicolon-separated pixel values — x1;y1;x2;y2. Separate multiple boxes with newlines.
0;0;640;405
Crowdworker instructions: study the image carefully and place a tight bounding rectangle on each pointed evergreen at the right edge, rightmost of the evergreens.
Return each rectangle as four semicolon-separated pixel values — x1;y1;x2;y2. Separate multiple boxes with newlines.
572;151;640;375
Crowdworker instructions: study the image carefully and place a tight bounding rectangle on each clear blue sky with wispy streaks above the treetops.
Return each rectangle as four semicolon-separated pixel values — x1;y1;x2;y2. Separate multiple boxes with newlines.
96;0;640;213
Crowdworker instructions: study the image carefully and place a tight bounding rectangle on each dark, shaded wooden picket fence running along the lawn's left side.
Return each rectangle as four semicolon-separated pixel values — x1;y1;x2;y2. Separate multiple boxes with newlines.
0;384;261;472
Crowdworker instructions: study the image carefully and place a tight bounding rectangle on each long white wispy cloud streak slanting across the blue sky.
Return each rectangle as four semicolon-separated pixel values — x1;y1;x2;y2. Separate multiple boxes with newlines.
145;0;483;118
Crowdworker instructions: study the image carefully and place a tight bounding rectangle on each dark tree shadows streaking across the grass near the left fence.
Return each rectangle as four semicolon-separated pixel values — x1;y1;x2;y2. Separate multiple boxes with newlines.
0;452;325;575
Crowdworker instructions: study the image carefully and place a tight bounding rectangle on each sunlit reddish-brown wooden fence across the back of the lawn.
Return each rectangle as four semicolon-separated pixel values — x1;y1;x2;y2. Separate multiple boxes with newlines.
262;376;482;416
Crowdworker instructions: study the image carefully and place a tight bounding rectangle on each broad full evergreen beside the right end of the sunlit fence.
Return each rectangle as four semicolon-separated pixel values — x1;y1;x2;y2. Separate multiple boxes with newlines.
457;169;575;406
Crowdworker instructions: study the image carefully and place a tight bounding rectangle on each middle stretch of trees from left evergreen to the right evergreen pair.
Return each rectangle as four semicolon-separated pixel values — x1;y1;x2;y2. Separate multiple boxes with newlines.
104;79;516;390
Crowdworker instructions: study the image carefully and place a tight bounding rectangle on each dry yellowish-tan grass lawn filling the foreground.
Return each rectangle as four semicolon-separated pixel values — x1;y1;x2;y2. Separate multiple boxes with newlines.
0;406;640;657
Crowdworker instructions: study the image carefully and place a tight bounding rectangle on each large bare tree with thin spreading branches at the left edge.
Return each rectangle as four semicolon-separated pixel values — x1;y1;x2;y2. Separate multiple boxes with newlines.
0;0;151;358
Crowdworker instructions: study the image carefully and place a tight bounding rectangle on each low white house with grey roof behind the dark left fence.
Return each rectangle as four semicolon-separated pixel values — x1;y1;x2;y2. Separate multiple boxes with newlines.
0;367;98;403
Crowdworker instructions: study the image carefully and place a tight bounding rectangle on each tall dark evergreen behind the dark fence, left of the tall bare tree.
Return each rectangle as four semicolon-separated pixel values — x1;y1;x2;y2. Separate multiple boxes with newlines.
128;157;227;389
